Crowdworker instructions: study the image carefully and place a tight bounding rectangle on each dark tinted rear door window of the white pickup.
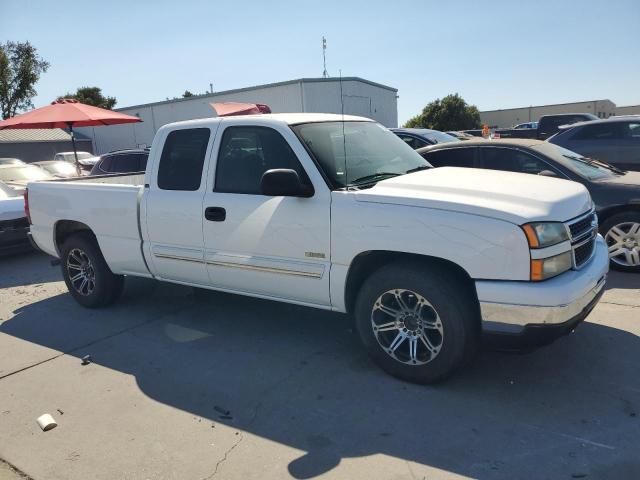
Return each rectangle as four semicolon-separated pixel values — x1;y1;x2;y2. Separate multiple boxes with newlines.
158;128;210;191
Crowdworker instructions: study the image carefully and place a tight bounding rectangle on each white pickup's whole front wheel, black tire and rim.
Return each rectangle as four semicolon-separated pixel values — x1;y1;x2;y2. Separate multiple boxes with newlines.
355;263;480;384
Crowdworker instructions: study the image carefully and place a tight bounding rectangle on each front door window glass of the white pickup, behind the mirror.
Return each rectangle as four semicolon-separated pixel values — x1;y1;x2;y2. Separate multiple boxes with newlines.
215;127;309;195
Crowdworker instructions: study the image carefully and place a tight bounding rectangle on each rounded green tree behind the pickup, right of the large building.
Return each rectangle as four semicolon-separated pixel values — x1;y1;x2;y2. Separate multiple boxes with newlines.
405;93;480;131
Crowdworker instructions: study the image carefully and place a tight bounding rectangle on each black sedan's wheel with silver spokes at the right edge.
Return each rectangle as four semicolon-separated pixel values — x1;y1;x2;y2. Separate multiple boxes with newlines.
600;211;640;273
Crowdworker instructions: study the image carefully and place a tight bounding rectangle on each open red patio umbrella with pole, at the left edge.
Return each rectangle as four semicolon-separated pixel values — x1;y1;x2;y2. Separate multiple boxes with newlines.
0;98;142;169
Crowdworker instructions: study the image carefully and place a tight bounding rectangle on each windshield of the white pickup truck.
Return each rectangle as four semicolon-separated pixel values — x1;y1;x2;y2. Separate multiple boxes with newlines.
291;122;431;188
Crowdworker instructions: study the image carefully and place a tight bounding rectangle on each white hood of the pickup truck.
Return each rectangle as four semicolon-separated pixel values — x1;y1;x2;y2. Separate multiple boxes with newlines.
356;167;592;225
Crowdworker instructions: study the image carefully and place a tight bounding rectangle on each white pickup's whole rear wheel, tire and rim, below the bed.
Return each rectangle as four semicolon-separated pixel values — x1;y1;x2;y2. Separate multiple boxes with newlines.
60;232;124;308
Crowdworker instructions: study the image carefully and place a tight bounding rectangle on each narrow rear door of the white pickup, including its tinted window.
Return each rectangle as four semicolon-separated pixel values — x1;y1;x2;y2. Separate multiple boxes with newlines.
141;124;217;285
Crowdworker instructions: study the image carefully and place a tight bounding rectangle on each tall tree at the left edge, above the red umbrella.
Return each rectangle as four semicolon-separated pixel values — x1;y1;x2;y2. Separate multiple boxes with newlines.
0;42;49;119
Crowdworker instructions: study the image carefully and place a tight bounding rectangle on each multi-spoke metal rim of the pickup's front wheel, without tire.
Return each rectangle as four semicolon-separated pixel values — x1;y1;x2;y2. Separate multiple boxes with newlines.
371;289;444;365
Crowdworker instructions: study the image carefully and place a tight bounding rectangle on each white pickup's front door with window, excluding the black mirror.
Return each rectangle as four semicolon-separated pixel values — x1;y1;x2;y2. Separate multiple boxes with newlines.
203;121;331;305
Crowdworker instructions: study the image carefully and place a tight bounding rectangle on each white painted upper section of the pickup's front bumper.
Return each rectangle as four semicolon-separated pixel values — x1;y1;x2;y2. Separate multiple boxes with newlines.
476;235;609;307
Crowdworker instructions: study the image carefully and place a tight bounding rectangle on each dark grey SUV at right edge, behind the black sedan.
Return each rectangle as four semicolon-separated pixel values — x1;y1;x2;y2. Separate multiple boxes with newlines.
549;115;640;171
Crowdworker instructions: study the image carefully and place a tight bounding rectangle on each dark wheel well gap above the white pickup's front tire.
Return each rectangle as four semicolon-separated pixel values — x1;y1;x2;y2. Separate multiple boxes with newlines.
345;250;480;319
